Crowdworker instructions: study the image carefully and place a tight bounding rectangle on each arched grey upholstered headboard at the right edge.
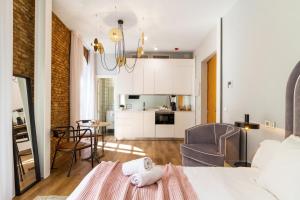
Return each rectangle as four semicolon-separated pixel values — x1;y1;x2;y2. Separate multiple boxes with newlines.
285;62;300;137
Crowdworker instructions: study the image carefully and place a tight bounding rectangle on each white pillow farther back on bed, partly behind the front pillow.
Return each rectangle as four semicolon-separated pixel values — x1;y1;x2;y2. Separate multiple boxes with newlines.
251;140;281;169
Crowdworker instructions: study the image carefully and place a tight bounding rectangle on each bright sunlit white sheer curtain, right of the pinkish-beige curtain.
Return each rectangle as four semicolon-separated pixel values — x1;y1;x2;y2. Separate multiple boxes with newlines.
80;51;96;119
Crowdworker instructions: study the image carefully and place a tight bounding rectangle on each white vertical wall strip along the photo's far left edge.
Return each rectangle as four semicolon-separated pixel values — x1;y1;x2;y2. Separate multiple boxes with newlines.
0;0;14;200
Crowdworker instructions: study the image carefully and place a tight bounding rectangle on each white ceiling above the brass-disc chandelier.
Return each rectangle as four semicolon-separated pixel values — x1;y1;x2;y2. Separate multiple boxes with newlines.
53;0;237;51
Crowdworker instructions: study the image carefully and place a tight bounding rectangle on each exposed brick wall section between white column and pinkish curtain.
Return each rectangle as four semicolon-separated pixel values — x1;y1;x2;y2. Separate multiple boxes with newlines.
51;13;71;127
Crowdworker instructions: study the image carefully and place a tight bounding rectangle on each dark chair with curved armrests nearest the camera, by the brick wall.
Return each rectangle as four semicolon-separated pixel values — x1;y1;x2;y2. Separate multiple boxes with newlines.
51;126;94;177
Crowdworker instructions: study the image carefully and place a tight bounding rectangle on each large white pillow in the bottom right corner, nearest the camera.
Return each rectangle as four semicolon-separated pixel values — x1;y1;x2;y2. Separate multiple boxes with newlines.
256;145;300;200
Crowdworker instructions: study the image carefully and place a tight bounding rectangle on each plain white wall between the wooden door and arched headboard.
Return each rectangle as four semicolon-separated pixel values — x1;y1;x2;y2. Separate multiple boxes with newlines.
223;0;300;160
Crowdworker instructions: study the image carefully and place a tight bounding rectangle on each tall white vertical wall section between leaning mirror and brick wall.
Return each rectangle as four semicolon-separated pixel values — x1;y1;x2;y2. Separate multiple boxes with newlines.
34;0;52;178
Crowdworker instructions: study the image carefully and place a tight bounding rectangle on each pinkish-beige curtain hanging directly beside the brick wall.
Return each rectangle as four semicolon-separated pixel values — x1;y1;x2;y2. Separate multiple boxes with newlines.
70;32;84;126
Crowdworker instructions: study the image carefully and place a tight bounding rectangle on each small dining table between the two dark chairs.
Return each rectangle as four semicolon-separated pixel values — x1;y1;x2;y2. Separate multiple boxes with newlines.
80;120;111;163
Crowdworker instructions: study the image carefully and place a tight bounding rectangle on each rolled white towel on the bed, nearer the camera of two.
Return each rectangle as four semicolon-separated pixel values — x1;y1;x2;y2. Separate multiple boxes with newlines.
130;166;163;187
